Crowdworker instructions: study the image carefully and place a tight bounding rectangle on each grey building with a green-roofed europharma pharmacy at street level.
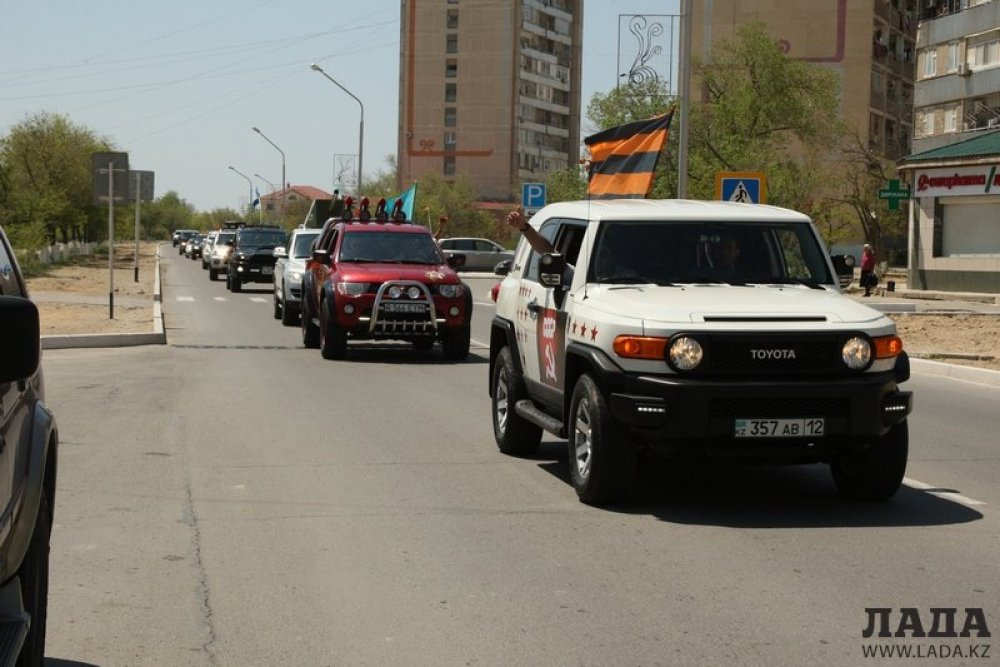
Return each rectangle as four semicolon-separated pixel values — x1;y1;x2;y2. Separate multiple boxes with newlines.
899;0;1000;293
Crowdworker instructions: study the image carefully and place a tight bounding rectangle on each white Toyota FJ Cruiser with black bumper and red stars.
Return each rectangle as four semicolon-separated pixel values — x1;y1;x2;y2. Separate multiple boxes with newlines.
489;200;912;503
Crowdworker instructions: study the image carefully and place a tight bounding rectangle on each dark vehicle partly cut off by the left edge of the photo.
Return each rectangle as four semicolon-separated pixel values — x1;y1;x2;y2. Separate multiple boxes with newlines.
0;228;59;665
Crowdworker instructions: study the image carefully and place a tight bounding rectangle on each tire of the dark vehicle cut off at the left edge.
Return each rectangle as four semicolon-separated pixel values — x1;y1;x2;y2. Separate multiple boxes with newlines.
17;490;52;667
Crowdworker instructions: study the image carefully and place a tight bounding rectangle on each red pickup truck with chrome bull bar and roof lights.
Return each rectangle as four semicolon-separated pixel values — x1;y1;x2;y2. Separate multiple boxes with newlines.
302;219;472;360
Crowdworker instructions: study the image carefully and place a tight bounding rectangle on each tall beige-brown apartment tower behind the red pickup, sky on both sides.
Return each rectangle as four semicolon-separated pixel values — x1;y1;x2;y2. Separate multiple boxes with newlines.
397;0;583;201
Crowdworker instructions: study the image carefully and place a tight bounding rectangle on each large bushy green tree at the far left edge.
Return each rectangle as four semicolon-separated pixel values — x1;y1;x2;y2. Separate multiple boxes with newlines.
0;113;111;245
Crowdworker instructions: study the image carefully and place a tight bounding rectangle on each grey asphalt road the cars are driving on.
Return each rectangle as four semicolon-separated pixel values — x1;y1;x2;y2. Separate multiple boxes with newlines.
44;253;1000;666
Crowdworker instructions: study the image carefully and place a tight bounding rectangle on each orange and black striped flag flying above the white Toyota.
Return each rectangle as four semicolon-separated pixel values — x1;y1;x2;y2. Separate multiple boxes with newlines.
583;109;674;199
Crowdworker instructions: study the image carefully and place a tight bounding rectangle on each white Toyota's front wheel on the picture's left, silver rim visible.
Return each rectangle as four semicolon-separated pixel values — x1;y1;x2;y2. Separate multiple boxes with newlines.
567;374;638;505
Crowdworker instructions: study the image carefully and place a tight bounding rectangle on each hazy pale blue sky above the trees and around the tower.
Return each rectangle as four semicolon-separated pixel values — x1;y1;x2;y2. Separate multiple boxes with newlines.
0;0;679;211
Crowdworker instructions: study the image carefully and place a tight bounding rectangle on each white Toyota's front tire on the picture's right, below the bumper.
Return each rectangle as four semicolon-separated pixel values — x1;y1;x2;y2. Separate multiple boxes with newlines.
830;421;910;501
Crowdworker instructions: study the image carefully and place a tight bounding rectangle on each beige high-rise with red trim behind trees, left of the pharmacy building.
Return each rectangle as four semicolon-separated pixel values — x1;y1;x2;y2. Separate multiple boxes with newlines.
691;0;926;160
